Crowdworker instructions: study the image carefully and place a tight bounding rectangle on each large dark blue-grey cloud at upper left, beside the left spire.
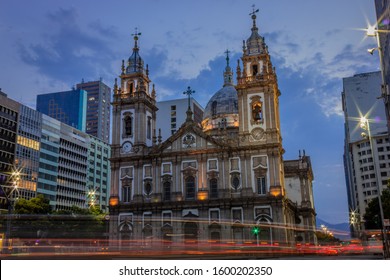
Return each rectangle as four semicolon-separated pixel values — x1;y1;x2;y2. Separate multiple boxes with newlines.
18;8;117;84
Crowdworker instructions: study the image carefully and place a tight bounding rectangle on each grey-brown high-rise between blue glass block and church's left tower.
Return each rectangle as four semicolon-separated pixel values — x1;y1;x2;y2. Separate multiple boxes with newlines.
76;80;111;143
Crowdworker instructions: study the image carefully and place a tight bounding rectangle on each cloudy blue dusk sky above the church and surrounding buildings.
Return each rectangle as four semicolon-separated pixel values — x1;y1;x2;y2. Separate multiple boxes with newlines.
0;0;379;223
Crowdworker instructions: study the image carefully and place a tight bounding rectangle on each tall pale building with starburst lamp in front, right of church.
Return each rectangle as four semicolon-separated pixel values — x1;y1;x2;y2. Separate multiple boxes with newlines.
342;71;390;233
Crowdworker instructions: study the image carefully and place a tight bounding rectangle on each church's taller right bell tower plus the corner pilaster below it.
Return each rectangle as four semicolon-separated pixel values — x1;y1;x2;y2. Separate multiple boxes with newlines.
236;8;284;195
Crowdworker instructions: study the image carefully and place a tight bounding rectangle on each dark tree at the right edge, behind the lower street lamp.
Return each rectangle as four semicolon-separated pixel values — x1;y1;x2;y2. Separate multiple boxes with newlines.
364;184;390;229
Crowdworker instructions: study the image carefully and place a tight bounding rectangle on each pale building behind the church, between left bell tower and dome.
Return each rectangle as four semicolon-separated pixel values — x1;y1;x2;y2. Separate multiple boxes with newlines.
156;98;204;141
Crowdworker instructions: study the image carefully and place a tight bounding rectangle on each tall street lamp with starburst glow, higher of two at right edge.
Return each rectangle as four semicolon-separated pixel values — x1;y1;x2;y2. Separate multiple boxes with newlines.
366;26;390;137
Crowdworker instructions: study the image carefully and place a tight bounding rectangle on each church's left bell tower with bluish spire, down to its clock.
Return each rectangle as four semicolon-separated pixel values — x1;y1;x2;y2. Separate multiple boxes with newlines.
112;31;158;155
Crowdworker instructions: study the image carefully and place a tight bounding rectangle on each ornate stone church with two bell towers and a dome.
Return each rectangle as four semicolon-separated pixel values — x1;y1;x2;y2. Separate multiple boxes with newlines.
109;11;316;249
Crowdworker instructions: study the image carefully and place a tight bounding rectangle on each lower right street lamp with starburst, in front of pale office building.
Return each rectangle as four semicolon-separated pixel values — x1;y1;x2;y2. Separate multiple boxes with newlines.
359;117;389;259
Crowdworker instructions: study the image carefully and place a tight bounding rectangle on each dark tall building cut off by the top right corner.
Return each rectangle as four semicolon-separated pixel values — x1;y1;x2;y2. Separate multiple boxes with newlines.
375;0;390;136
